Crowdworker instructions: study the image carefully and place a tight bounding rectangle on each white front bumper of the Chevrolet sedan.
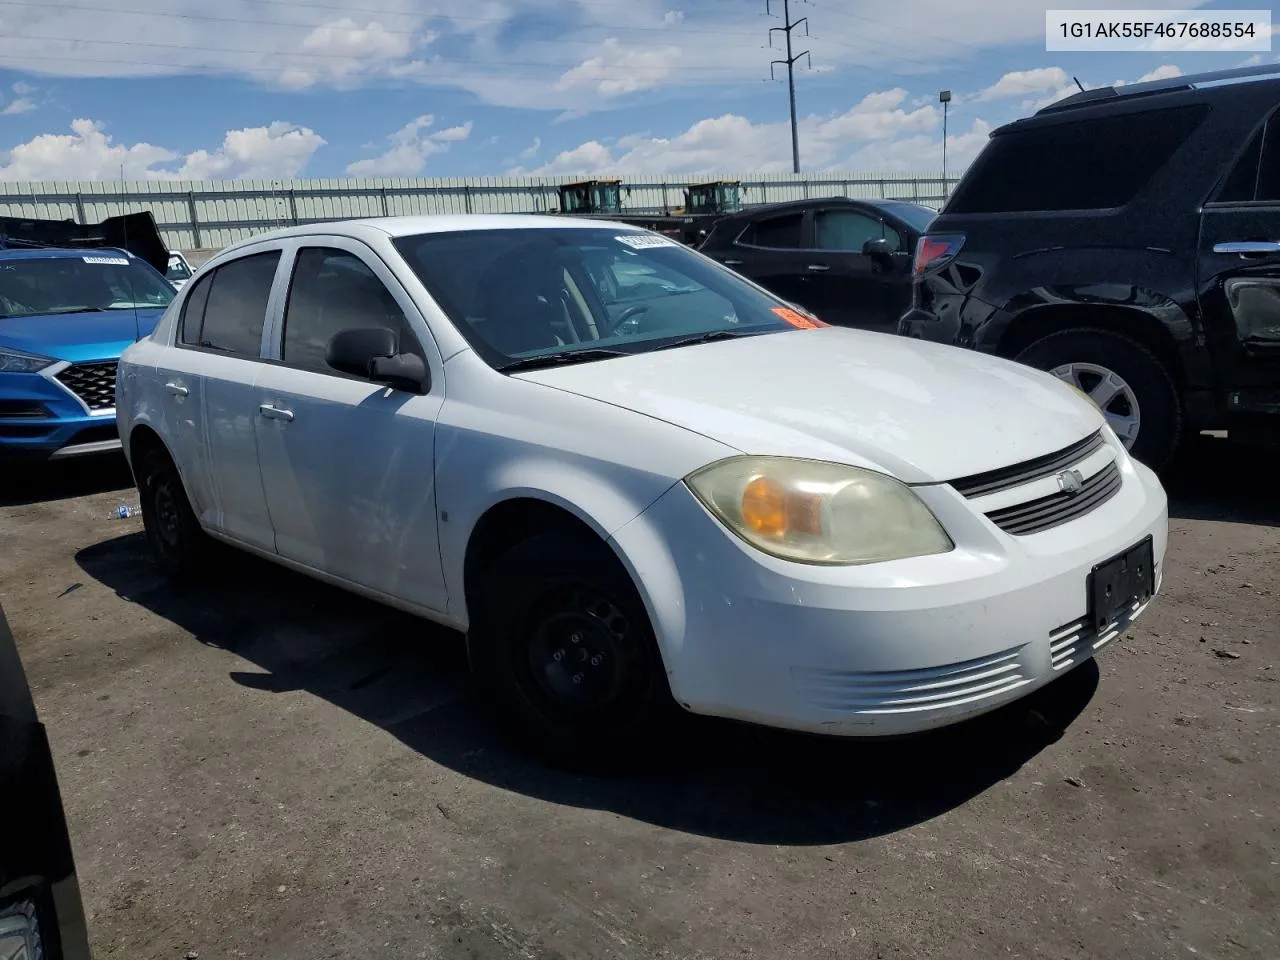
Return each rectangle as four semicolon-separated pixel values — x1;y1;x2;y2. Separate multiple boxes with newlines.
614;457;1169;736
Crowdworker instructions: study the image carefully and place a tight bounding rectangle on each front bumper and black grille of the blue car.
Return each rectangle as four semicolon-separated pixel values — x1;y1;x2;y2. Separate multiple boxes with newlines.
0;360;120;460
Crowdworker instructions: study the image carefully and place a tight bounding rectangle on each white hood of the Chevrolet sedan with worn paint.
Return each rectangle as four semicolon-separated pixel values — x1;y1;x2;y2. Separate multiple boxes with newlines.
517;326;1102;483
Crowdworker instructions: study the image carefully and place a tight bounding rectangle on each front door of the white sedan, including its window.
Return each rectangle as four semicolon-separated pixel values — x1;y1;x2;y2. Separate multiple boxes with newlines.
255;244;447;611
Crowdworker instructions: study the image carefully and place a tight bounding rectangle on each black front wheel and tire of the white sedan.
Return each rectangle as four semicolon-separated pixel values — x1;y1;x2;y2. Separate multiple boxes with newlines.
467;531;680;773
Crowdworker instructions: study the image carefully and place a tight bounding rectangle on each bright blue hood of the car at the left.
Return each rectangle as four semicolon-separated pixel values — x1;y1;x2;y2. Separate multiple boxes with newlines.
0;307;164;364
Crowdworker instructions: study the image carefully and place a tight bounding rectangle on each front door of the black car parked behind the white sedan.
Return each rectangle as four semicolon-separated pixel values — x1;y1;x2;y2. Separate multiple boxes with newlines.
805;206;911;333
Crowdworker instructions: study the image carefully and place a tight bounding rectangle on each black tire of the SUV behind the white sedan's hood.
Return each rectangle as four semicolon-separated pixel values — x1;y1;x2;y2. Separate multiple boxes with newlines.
1014;328;1183;472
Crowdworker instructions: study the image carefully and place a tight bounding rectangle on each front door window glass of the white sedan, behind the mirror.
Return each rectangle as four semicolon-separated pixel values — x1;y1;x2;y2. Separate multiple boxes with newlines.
280;247;422;374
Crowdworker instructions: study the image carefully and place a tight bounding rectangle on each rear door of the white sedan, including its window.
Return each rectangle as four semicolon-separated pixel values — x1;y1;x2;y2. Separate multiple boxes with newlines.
157;247;280;550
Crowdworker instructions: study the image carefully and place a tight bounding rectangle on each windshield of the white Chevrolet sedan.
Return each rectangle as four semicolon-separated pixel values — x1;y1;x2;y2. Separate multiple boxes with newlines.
396;227;815;369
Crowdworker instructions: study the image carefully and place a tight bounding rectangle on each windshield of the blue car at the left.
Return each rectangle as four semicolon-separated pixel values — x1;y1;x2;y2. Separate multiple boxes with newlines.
0;252;175;317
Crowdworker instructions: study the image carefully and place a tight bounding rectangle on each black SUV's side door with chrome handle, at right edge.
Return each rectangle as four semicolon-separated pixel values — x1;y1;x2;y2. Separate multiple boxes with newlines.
1198;106;1280;399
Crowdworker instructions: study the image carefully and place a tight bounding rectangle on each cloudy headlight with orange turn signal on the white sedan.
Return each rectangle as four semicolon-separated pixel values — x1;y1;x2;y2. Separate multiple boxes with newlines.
685;457;955;564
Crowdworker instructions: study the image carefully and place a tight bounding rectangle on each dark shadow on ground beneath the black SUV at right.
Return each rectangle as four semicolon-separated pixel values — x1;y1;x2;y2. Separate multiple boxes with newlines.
1164;435;1280;526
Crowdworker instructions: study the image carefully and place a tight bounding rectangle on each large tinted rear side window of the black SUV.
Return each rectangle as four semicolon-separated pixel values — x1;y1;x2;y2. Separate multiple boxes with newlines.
946;104;1208;214
